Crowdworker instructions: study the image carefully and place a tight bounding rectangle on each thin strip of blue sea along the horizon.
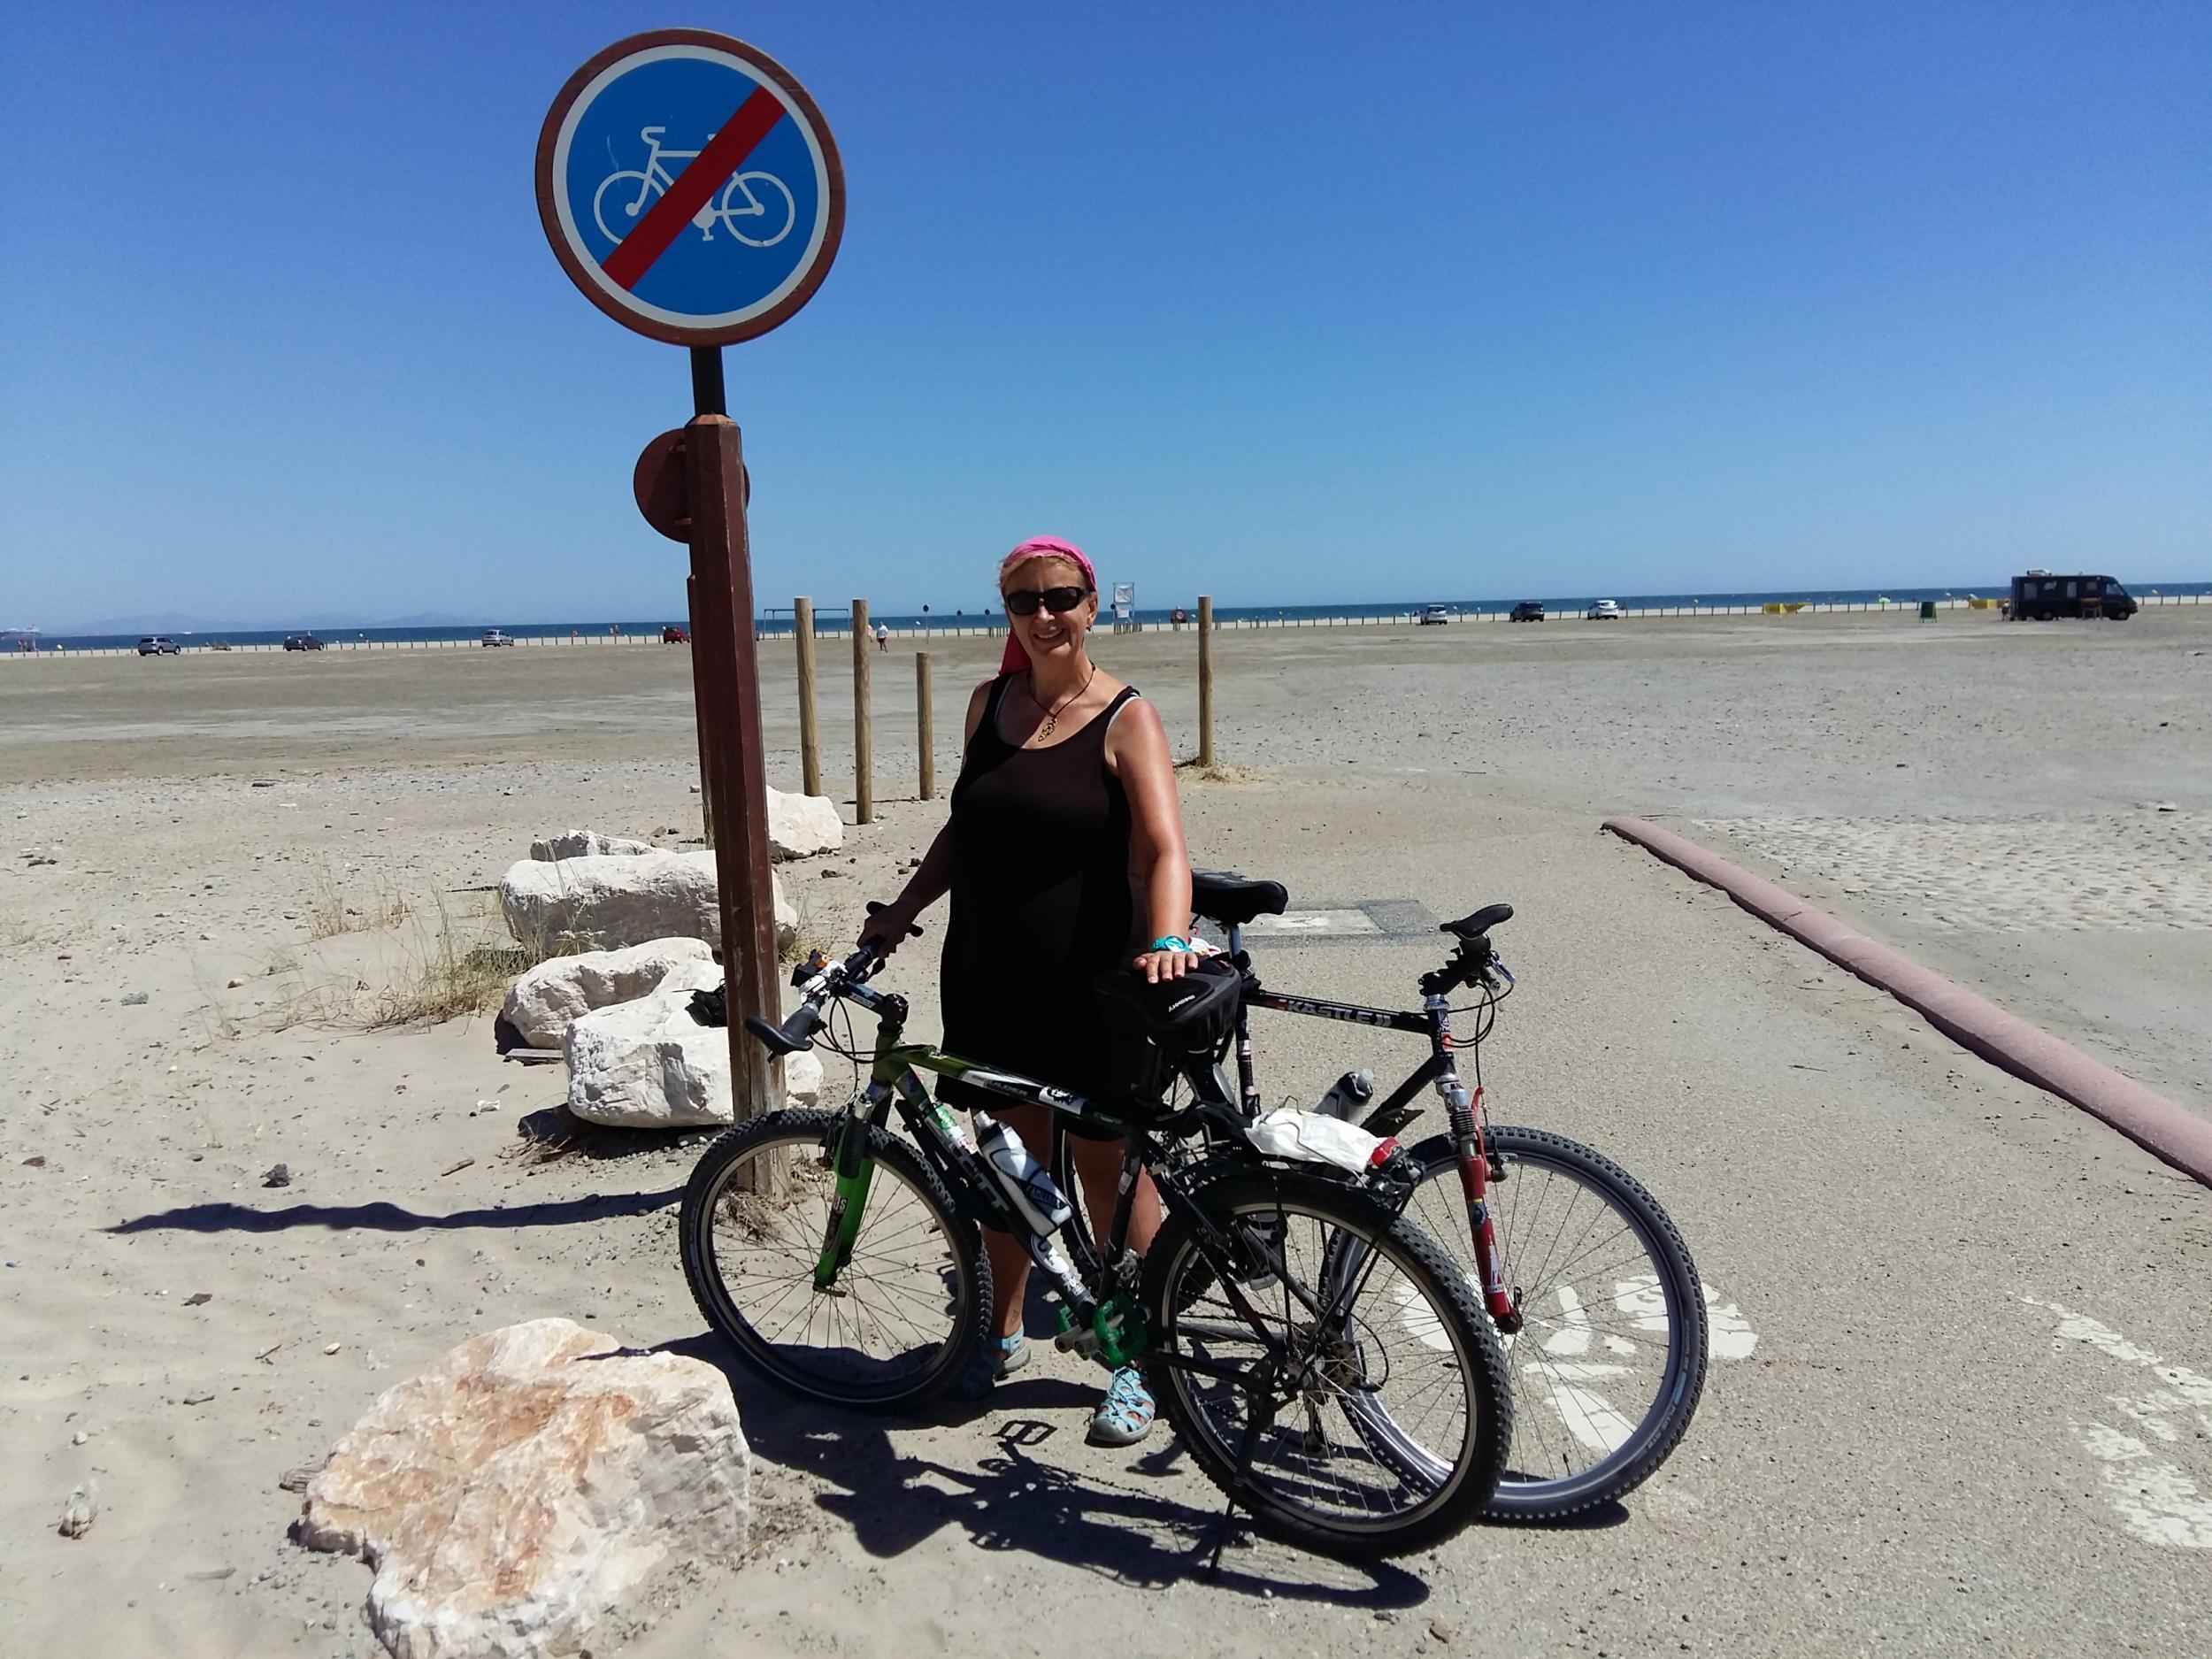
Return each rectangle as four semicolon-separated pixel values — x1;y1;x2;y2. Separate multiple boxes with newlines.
0;578;2212;650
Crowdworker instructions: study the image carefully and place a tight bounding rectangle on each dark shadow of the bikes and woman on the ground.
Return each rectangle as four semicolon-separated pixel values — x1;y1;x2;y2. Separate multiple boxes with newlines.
659;1332;1429;1610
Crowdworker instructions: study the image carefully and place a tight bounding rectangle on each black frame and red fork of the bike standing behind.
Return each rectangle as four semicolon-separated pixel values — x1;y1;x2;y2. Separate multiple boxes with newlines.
1228;923;1522;1336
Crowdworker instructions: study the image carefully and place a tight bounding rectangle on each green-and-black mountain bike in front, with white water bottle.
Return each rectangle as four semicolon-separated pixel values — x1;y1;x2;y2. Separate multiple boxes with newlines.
680;929;1511;1557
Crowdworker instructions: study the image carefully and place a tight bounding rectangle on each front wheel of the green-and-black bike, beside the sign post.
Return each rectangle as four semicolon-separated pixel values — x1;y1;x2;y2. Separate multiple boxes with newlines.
677;1110;991;1411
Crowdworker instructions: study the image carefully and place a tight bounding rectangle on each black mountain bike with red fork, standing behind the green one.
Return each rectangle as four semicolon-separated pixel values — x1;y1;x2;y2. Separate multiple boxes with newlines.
1053;872;1706;1520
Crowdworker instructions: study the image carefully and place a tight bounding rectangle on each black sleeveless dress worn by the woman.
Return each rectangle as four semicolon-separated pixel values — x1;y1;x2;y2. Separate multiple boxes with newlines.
941;675;1137;1109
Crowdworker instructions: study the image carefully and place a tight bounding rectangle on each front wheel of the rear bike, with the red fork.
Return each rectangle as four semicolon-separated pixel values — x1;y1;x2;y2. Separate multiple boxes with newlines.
1405;1128;1706;1520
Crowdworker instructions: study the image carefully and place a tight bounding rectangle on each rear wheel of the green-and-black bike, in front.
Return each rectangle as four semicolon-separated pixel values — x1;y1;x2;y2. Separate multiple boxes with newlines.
1144;1171;1511;1557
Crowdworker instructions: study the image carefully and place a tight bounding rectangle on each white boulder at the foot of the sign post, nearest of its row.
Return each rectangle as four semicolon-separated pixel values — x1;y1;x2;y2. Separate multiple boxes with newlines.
569;989;823;1128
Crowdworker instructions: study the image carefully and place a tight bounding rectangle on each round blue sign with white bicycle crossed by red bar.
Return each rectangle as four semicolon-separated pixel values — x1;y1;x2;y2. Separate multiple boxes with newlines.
538;29;845;345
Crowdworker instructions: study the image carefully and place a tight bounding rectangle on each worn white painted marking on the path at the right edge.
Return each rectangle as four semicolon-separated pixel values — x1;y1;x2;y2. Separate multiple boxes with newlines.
2020;1296;2212;1551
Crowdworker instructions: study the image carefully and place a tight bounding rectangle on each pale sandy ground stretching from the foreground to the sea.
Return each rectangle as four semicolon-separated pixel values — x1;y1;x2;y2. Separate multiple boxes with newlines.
0;606;2212;1659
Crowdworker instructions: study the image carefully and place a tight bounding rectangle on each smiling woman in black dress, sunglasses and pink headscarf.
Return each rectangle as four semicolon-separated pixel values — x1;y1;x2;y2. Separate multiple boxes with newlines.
861;535;1197;1447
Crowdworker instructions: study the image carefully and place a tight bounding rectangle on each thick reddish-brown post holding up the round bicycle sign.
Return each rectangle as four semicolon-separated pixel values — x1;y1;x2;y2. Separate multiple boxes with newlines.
684;414;783;1122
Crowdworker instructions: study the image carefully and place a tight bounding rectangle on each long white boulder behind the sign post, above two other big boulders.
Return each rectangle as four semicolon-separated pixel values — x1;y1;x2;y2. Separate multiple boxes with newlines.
500;852;799;954
